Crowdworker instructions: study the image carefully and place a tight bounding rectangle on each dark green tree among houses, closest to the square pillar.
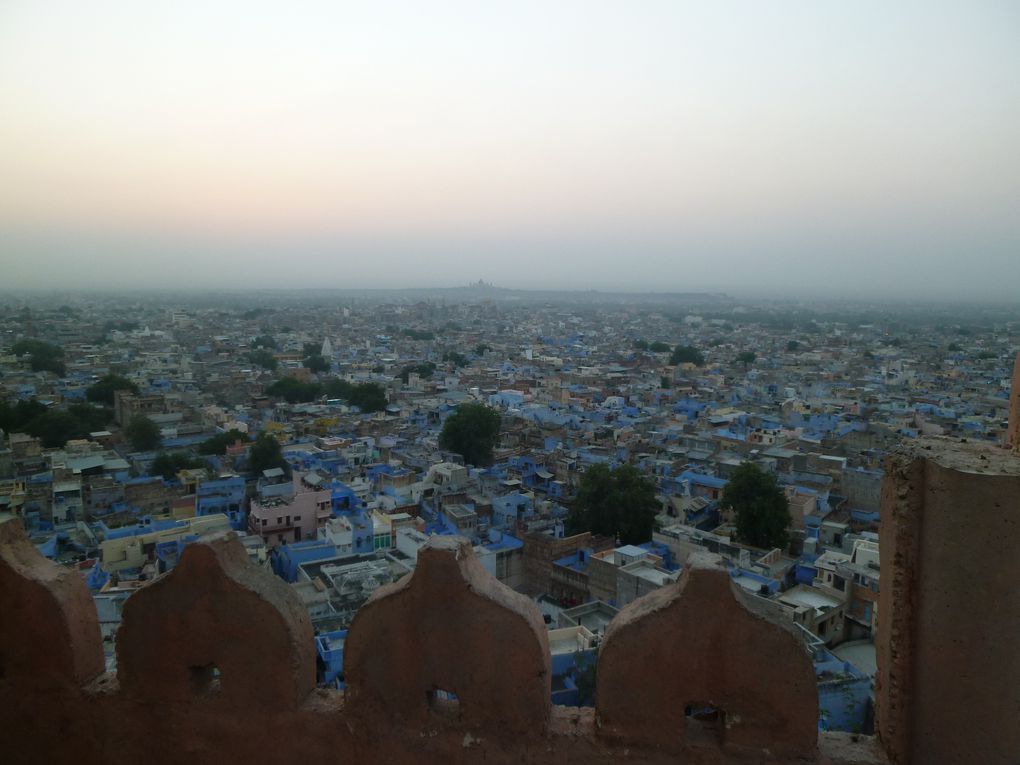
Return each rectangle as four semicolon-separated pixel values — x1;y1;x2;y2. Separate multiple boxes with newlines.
720;462;789;550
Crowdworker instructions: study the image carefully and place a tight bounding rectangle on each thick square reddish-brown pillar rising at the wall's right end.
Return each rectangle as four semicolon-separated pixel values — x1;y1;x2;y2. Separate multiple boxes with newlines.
875;439;1020;765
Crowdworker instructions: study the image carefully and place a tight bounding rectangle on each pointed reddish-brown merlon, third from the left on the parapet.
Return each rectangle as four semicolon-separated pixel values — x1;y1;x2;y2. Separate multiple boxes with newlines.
344;537;551;734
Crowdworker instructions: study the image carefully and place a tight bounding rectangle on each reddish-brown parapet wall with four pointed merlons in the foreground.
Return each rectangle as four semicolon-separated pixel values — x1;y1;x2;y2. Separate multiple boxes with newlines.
0;520;885;765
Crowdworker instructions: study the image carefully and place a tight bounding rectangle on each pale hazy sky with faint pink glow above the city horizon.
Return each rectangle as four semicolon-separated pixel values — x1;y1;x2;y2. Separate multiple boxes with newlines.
0;0;1020;300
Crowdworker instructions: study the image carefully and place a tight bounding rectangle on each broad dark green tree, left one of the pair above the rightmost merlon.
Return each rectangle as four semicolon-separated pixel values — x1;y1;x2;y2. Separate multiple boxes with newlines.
567;464;659;545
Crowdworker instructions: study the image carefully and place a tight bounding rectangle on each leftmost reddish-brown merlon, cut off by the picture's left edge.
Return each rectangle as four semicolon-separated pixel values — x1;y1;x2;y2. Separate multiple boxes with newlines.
0;519;104;692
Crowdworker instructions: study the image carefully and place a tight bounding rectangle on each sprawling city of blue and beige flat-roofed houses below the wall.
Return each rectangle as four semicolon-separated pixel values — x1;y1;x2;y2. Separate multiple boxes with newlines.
0;281;1020;762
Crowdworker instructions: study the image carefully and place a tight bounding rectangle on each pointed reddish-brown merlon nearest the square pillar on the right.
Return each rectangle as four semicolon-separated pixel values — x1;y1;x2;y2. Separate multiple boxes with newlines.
597;553;818;756
